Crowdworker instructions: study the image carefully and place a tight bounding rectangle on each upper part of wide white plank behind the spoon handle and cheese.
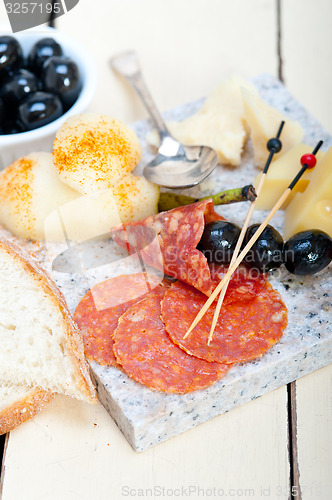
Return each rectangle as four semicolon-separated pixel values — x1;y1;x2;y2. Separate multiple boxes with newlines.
57;0;277;122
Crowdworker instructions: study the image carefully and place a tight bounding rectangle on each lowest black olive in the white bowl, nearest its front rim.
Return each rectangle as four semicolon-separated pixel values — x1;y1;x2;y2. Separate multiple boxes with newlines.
18;92;63;130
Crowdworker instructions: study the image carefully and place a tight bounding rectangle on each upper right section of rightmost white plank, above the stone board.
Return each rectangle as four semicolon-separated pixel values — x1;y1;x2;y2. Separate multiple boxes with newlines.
281;0;332;133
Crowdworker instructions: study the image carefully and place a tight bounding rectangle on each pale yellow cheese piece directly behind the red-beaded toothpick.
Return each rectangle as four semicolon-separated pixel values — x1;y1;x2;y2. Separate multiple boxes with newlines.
254;143;324;210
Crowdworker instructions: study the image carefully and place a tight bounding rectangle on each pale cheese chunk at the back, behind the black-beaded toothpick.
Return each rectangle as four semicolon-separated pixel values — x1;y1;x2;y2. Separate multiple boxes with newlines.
241;87;304;168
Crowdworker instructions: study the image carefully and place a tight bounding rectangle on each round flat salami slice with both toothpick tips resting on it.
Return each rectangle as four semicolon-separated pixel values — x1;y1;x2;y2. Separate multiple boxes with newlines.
162;281;287;363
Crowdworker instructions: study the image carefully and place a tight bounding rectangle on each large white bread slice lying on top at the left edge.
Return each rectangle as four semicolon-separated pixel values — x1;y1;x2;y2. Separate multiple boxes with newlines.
0;240;97;411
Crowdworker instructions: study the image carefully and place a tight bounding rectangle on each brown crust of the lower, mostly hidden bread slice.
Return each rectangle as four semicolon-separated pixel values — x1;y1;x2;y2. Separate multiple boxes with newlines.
0;387;55;435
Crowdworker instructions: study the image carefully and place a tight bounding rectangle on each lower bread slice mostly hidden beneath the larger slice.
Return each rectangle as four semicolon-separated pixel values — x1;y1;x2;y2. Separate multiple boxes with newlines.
0;385;55;435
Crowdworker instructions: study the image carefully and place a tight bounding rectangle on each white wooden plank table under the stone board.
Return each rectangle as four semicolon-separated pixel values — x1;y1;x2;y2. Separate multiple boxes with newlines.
0;0;332;500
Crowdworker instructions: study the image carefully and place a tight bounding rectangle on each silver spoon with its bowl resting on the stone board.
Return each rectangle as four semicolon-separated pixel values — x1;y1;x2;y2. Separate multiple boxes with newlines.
110;51;218;188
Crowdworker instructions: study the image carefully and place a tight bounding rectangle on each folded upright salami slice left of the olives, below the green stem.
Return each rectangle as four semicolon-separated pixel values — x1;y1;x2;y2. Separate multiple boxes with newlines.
112;199;224;295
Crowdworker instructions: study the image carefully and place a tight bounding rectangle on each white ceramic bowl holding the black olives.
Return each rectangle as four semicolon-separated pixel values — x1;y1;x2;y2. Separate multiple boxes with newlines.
0;28;97;169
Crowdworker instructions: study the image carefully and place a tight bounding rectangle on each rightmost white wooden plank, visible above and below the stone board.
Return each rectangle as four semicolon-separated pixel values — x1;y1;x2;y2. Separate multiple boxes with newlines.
281;0;332;500
